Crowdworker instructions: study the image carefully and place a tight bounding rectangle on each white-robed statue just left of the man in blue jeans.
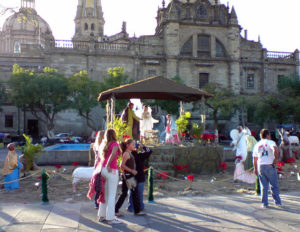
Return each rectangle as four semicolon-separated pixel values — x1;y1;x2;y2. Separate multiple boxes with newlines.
230;126;256;184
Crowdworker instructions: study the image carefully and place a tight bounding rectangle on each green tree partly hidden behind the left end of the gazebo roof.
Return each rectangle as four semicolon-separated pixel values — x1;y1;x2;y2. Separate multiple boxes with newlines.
101;67;133;113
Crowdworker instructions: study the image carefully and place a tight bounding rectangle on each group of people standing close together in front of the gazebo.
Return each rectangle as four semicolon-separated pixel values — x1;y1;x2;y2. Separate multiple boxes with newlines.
87;129;152;224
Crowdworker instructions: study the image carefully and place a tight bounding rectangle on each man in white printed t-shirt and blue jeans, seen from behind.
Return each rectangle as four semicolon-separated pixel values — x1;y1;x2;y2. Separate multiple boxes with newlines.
253;129;281;208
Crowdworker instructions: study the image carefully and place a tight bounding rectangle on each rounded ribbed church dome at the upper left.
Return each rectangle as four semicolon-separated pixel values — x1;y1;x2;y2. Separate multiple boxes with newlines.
2;8;52;35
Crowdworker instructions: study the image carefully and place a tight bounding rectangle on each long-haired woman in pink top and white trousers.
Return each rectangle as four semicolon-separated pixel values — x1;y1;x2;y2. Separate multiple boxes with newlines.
98;129;121;224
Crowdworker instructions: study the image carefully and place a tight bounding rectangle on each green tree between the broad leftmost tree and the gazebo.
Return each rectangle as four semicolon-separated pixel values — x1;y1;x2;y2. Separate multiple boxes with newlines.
68;71;101;130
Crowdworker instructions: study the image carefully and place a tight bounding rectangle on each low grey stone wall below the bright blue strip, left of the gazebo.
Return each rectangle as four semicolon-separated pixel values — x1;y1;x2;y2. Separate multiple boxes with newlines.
36;151;89;166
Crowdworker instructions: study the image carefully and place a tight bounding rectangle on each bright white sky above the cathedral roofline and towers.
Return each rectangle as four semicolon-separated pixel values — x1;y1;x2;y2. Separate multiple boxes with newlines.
0;0;300;52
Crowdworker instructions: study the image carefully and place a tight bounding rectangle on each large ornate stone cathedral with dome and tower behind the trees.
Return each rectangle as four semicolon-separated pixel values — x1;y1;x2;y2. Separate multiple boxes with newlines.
0;0;299;137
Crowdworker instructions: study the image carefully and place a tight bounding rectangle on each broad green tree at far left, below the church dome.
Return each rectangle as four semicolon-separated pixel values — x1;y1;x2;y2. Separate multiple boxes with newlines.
8;65;69;131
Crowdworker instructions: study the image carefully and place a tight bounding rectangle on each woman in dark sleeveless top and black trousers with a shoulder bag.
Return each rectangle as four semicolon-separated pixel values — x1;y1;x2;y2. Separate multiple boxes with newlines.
115;139;145;217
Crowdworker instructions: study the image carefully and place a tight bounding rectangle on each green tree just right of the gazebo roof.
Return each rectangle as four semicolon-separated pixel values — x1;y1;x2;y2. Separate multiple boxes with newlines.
193;82;237;130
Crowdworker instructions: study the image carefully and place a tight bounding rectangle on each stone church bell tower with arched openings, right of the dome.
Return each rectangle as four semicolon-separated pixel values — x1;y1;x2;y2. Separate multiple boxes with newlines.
73;0;104;41
